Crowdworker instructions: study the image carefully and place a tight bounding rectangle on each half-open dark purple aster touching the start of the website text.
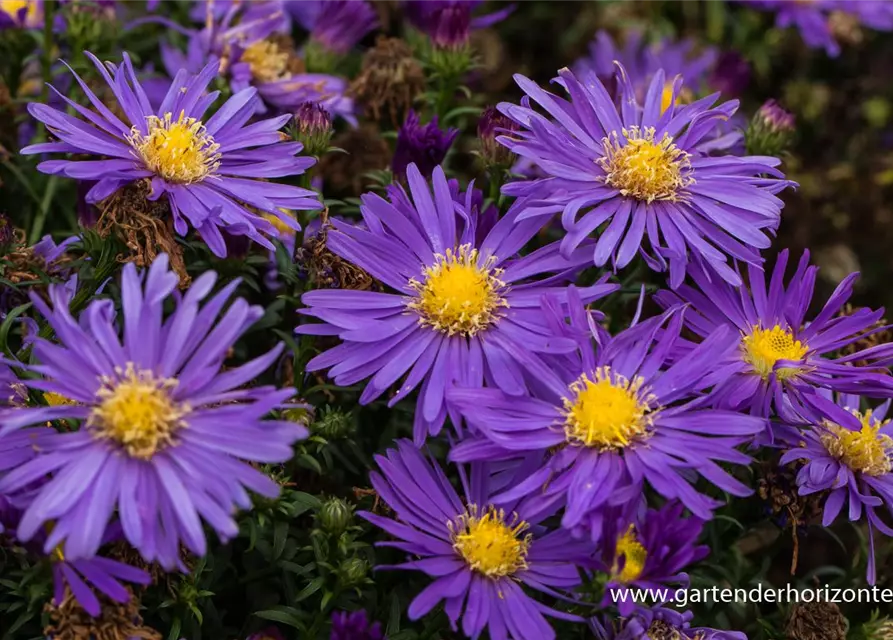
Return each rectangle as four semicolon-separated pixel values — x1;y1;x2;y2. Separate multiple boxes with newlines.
599;502;710;617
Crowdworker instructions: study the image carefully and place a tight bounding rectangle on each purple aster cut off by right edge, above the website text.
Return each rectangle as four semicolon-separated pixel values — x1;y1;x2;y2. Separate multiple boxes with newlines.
780;392;893;584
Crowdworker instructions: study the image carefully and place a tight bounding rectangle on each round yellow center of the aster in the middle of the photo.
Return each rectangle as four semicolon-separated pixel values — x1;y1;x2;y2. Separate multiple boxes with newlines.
406;244;508;336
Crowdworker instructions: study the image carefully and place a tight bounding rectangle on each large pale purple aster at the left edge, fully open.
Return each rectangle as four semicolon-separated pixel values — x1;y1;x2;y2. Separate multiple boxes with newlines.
0;254;306;568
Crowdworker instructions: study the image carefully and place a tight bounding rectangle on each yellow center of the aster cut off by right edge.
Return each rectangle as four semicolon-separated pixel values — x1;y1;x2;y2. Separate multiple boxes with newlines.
822;409;893;476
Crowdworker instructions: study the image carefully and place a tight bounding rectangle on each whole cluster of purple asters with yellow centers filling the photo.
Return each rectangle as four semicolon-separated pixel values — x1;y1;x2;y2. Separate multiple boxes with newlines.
0;0;893;640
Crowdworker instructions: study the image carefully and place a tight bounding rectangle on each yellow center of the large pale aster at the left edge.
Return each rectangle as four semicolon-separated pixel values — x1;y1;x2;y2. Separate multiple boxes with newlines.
87;363;189;460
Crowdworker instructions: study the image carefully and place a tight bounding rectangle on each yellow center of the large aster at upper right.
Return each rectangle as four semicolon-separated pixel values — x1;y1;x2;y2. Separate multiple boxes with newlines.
598;127;694;203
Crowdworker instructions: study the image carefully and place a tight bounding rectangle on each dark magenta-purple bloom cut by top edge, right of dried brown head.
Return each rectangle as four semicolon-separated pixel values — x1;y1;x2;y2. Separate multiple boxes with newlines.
403;0;515;48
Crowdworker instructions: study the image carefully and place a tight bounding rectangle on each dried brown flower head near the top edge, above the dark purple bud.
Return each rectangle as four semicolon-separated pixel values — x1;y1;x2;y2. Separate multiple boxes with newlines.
349;36;425;126
